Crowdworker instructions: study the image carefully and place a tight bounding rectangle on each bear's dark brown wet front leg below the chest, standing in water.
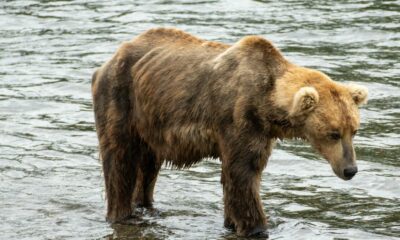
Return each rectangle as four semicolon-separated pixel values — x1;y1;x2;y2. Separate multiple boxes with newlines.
221;136;268;238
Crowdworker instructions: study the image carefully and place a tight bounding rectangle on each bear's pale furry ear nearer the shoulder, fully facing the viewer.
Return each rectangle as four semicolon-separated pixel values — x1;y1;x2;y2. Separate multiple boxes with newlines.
289;87;319;117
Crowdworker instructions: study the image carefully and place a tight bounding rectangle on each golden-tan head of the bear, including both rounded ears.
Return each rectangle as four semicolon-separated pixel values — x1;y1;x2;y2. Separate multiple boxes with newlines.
275;66;368;180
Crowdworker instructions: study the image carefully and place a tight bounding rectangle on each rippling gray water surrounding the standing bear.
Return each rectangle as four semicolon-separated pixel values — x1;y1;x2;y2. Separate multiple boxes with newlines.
0;0;400;239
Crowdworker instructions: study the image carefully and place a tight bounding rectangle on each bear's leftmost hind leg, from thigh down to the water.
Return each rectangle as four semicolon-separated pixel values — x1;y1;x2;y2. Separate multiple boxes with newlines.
94;99;140;223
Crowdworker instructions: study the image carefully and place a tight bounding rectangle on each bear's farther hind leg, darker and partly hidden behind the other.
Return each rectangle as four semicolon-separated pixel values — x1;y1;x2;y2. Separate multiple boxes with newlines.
133;142;162;208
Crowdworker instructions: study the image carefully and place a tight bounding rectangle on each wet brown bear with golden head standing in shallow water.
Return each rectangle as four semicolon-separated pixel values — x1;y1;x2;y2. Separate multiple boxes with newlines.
92;28;367;237
